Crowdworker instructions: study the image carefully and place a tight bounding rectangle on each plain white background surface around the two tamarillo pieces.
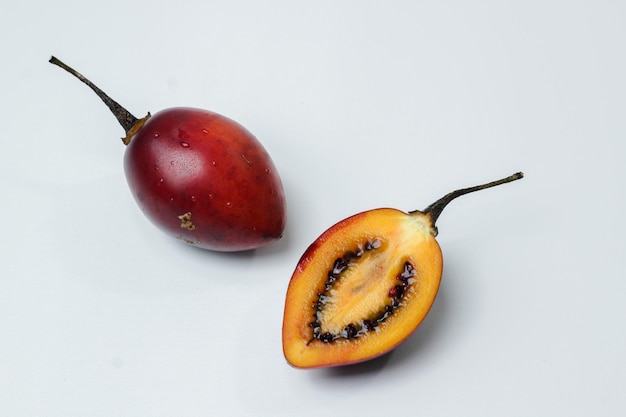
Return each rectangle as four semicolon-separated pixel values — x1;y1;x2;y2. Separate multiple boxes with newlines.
0;0;626;417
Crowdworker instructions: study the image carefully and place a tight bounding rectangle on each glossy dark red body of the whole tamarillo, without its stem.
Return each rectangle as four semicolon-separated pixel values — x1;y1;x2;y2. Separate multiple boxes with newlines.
124;108;286;252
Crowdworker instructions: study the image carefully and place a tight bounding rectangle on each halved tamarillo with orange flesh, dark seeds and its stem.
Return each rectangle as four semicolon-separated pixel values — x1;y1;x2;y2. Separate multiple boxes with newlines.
282;172;523;368
